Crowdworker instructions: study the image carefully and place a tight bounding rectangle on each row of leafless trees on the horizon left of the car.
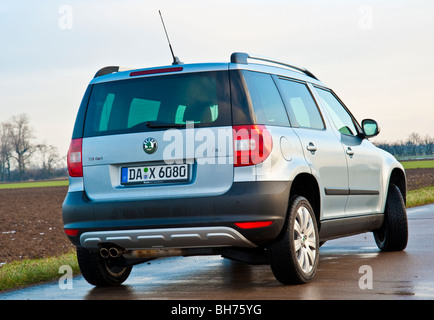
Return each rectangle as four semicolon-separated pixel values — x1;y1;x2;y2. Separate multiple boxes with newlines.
0;113;66;181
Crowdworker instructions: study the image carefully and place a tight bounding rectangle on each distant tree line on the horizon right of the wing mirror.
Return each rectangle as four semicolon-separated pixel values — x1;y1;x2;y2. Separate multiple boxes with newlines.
375;133;434;159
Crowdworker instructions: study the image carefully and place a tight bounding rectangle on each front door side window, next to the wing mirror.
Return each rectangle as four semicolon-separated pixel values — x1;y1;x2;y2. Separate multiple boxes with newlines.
315;88;357;136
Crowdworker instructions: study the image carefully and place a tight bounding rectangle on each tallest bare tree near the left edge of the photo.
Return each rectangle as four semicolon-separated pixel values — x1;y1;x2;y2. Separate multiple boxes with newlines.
7;113;35;180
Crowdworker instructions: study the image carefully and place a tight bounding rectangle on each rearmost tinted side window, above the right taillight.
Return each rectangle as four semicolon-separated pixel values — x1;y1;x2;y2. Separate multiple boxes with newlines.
243;71;289;126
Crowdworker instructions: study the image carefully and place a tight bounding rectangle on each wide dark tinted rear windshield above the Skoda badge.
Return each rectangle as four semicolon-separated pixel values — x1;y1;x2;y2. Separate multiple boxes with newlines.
84;71;231;137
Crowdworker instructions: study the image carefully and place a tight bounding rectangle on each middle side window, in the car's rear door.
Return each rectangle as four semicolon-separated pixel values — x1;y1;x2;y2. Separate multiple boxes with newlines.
279;79;325;129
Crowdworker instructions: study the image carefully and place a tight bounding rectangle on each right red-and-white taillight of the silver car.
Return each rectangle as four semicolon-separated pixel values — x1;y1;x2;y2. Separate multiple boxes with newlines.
232;125;273;167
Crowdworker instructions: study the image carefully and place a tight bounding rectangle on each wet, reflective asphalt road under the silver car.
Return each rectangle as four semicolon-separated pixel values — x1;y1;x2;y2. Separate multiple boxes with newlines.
0;205;434;300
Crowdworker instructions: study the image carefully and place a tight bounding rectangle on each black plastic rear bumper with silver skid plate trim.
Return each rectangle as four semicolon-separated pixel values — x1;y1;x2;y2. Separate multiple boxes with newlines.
62;181;291;249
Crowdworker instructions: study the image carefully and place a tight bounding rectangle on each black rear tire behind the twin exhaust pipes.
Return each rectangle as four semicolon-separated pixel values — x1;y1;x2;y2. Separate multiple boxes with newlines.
77;247;132;287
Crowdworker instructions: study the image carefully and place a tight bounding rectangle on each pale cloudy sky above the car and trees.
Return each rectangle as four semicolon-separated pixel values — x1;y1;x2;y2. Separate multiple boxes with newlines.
0;0;434;154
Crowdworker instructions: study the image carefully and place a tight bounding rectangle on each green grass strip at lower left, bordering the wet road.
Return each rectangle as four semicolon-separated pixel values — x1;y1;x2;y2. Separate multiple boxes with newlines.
0;250;80;292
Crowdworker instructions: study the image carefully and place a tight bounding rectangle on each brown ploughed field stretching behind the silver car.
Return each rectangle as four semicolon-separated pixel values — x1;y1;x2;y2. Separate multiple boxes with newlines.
0;168;434;265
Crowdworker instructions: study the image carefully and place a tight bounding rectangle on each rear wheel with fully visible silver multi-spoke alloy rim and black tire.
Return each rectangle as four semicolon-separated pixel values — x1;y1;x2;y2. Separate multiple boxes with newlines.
267;196;319;284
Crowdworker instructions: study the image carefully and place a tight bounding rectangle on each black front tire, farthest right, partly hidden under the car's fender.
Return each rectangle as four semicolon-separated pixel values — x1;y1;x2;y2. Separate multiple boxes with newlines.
374;184;408;251
